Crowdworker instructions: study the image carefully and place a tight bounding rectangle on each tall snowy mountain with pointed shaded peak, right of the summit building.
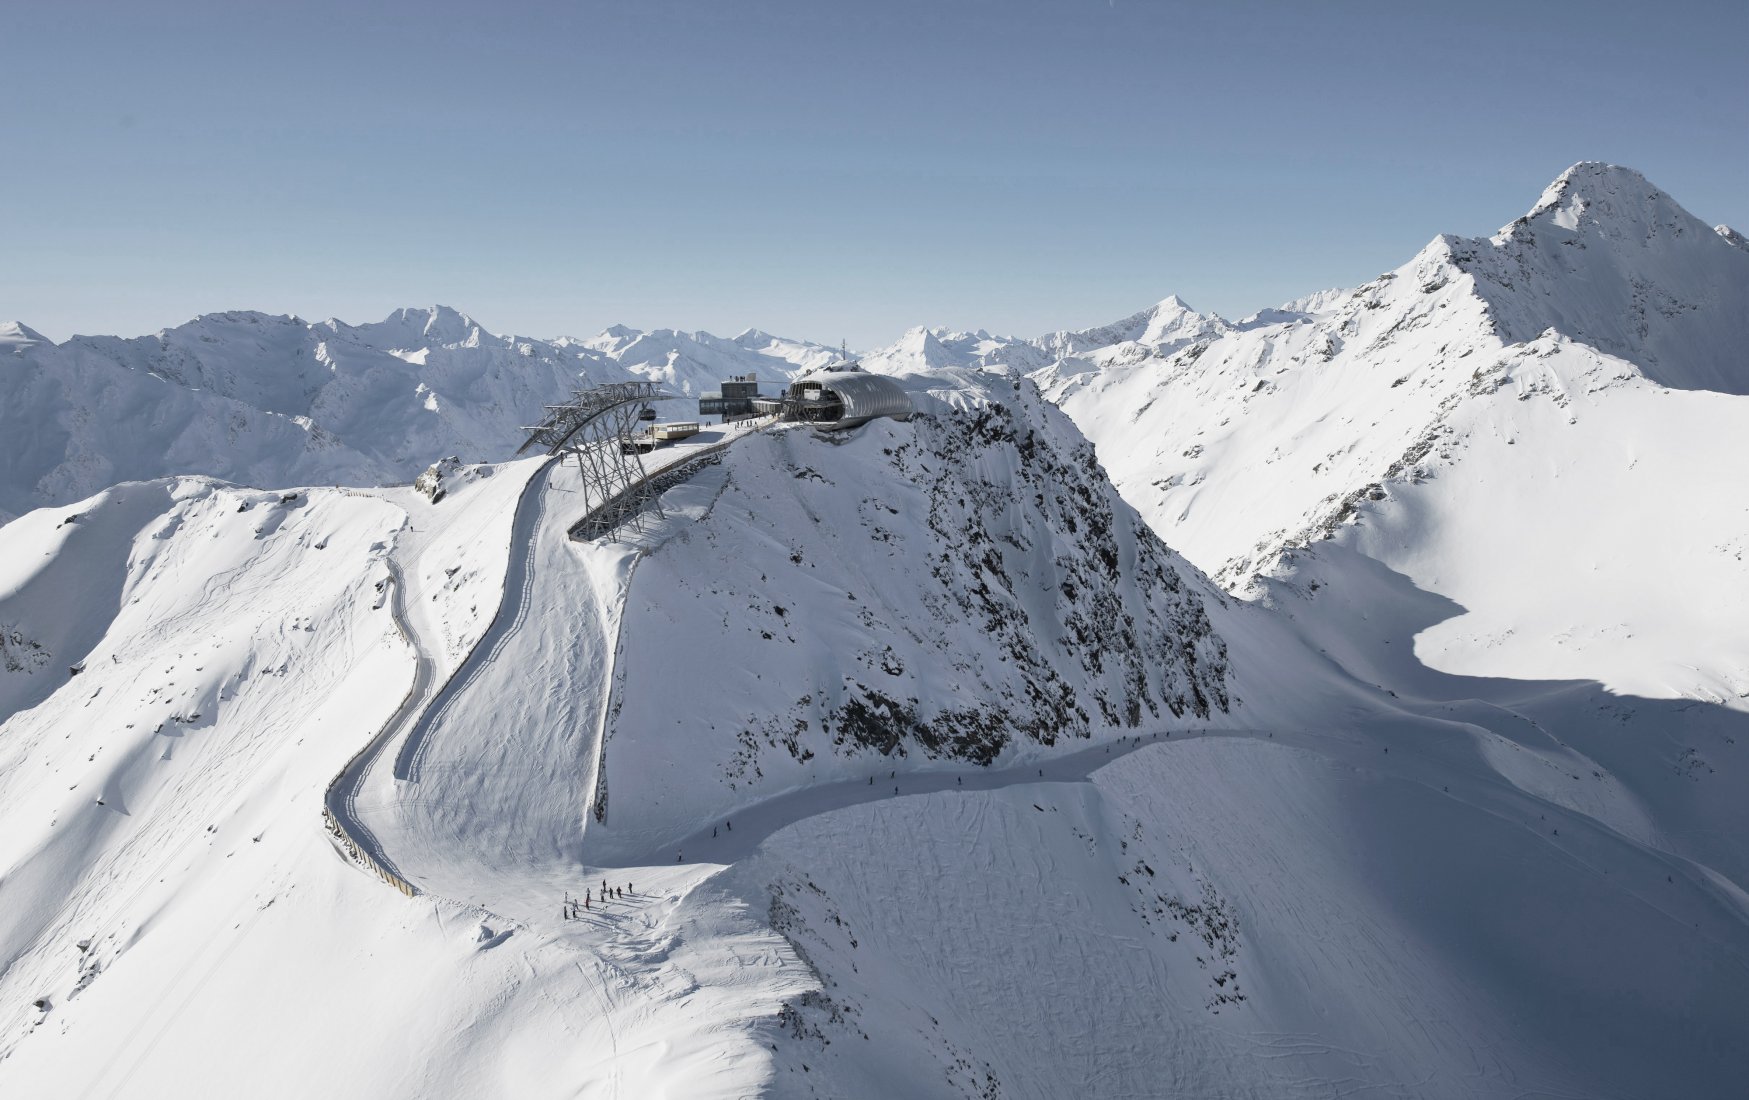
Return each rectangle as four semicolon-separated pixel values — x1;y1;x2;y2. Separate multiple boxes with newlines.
1034;164;1749;713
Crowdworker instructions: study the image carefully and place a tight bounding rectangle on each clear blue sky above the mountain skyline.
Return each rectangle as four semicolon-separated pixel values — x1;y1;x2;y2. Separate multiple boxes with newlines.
0;0;1749;346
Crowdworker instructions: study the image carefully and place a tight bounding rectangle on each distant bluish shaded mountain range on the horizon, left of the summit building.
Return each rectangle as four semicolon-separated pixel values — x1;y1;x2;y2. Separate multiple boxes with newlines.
0;306;834;521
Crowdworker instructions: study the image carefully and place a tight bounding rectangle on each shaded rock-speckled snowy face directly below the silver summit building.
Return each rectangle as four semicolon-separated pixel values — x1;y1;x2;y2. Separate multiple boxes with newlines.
591;372;1230;859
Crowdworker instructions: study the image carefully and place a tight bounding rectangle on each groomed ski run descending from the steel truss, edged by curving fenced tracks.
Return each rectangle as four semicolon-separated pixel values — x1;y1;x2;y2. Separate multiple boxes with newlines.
331;428;762;911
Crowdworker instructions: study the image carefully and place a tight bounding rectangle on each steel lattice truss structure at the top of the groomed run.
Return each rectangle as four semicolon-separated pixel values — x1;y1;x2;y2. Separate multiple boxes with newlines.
516;381;675;540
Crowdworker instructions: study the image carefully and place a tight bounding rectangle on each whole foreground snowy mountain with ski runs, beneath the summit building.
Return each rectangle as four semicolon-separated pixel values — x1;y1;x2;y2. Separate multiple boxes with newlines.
0;356;1749;1097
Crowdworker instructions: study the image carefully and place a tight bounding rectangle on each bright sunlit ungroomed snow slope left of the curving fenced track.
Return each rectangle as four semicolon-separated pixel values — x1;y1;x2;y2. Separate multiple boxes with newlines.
0;462;804;1097
